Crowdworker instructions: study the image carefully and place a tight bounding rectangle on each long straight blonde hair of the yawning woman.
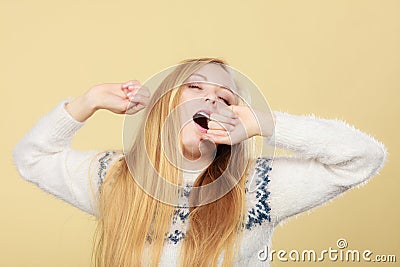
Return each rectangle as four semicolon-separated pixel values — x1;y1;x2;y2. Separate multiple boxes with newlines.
93;58;251;267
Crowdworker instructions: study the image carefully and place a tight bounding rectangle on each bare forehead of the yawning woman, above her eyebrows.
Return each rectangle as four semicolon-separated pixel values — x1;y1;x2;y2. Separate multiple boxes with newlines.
187;63;236;92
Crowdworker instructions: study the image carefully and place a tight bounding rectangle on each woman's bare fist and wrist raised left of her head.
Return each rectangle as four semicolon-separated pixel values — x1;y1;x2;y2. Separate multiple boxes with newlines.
66;80;150;122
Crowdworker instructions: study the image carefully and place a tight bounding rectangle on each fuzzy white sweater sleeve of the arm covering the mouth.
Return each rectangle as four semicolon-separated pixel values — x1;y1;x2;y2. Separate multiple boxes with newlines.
247;111;387;224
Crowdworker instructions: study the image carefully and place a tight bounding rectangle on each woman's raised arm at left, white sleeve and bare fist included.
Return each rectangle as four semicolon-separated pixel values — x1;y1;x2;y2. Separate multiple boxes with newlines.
13;81;147;218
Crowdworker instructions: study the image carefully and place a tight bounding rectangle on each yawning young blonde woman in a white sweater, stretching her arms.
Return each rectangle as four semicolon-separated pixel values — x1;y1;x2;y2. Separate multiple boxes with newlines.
13;58;387;266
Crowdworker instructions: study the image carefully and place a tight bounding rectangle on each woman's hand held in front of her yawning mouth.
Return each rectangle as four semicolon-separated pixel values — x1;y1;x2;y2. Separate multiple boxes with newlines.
205;105;273;145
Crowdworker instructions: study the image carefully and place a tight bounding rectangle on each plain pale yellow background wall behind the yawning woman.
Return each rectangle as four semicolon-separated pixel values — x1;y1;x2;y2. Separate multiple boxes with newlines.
0;0;400;266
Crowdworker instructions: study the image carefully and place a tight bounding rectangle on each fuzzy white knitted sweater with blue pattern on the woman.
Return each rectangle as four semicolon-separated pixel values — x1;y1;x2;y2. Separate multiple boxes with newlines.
13;98;387;266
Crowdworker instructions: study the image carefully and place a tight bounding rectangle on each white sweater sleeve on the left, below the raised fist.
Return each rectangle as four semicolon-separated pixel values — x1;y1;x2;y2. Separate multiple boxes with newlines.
13;98;122;218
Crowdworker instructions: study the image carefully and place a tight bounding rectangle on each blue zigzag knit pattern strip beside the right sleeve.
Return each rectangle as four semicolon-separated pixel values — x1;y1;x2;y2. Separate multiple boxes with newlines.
245;158;272;230
